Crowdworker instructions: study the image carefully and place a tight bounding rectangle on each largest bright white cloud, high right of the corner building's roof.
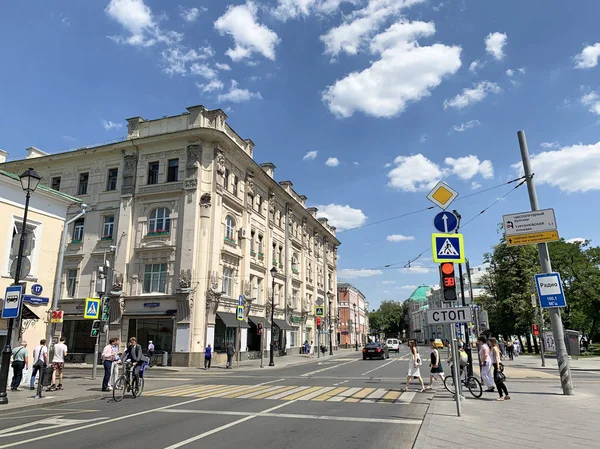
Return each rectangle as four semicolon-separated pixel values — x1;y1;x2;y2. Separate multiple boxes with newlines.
322;19;462;117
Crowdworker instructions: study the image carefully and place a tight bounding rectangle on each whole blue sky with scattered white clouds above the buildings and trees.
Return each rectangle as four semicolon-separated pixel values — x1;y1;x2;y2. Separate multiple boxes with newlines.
0;0;600;307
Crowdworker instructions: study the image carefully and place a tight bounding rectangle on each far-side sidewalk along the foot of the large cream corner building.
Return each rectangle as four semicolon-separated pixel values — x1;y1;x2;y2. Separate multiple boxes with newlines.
0;349;356;412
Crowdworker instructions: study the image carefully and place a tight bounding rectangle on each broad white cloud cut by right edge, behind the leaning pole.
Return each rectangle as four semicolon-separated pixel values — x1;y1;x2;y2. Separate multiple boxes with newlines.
512;142;600;193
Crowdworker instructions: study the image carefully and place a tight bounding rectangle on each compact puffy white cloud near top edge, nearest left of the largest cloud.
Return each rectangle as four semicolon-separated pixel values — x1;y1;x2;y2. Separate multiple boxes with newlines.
214;0;279;61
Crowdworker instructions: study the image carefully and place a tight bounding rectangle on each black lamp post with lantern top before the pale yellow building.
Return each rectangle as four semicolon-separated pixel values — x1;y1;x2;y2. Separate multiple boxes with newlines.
0;168;42;405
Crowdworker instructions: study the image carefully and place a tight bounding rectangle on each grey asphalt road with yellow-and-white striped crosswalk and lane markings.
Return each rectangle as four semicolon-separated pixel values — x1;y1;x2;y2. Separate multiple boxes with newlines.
0;348;432;449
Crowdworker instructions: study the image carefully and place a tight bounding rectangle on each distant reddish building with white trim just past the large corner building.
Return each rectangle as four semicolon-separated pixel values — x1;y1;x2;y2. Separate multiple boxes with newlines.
337;282;369;348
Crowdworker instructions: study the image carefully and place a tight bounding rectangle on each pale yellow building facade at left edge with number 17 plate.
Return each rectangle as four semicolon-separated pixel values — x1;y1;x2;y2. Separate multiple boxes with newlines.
0;164;79;348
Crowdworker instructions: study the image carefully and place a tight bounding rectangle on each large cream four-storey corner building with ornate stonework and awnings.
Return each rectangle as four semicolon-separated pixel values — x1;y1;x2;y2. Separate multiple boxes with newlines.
0;106;340;366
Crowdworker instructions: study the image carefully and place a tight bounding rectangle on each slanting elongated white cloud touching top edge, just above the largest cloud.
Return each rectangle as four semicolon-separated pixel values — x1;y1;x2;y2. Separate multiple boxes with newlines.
321;0;424;57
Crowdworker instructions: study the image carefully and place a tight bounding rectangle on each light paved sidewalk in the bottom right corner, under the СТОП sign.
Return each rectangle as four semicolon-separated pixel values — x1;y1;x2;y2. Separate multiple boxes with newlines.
413;373;600;449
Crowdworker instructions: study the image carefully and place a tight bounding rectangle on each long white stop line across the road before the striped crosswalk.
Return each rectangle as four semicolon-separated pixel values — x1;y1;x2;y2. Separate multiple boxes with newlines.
160;410;422;424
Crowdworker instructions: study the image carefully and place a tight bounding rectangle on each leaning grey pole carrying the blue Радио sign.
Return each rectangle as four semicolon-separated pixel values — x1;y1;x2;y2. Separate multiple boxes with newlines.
517;131;573;395
